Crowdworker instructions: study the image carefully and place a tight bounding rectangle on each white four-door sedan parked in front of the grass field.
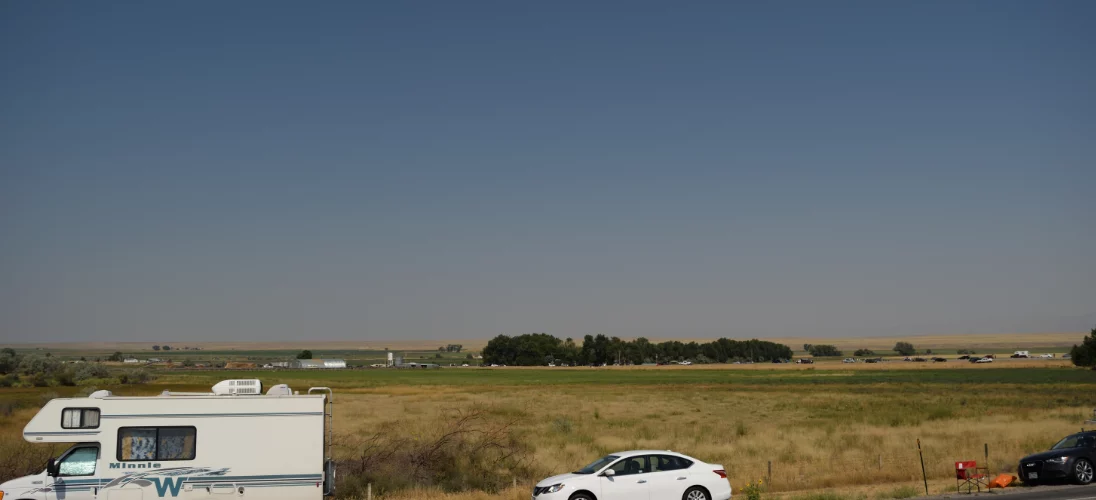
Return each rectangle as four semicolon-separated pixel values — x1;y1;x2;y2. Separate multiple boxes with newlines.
533;451;731;500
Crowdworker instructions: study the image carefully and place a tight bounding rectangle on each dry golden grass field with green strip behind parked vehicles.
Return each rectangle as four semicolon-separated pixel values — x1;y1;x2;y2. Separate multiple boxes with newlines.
0;360;1096;500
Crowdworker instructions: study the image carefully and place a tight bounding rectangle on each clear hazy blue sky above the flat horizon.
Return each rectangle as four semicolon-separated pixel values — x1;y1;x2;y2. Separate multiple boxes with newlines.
0;0;1096;342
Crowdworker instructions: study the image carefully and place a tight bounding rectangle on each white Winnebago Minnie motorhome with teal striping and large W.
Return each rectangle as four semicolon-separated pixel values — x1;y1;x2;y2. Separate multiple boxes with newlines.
0;379;334;500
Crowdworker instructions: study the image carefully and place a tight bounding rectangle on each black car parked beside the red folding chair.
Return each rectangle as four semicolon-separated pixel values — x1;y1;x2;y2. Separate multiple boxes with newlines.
1017;431;1096;485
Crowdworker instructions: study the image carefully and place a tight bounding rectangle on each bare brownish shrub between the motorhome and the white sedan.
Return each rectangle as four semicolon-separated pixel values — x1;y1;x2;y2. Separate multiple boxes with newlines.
338;407;532;498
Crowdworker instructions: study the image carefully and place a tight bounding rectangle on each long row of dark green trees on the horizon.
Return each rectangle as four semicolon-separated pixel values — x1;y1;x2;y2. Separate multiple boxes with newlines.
483;333;791;366
